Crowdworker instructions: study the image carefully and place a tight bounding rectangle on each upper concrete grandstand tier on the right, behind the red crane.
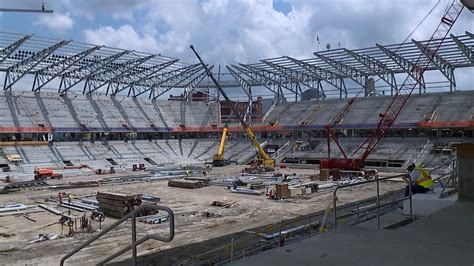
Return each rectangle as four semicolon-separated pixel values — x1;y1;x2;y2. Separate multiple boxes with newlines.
262;91;474;129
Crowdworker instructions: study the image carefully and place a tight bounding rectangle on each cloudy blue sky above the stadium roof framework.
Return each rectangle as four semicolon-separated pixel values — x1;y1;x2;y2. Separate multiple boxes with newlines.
0;0;474;64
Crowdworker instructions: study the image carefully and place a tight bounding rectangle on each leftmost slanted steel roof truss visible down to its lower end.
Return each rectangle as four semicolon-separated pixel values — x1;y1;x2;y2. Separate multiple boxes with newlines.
3;40;71;90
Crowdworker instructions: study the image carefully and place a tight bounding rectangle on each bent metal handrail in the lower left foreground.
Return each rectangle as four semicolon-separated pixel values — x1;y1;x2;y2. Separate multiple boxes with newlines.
60;204;174;266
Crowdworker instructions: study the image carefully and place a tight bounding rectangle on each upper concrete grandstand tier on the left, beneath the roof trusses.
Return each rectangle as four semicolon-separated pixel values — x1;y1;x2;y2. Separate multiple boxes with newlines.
0;91;220;133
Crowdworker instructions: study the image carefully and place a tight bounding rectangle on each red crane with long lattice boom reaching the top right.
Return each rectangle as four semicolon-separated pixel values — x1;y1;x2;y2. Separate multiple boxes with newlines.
320;0;469;172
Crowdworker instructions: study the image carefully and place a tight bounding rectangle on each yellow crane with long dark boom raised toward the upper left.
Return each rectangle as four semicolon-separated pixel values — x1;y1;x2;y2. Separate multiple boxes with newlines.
190;45;275;170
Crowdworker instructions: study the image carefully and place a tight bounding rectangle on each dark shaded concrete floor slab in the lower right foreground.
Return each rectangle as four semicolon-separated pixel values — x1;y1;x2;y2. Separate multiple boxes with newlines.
234;202;474;266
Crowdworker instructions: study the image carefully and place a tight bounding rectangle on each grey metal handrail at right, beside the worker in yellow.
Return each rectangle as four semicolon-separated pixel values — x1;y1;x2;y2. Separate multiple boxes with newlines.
333;174;413;229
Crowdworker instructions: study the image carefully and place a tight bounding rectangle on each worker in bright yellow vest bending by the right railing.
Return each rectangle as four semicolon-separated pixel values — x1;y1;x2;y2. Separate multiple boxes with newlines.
403;163;434;197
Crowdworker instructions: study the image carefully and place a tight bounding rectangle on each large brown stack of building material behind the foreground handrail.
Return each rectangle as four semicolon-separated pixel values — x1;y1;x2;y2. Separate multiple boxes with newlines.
96;192;142;218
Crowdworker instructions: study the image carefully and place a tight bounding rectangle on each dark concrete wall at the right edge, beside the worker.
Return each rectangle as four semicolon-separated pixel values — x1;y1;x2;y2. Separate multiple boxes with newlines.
457;143;474;202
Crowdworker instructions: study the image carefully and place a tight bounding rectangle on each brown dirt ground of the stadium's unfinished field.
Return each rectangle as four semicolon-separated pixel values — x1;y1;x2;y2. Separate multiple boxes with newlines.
0;166;404;265
